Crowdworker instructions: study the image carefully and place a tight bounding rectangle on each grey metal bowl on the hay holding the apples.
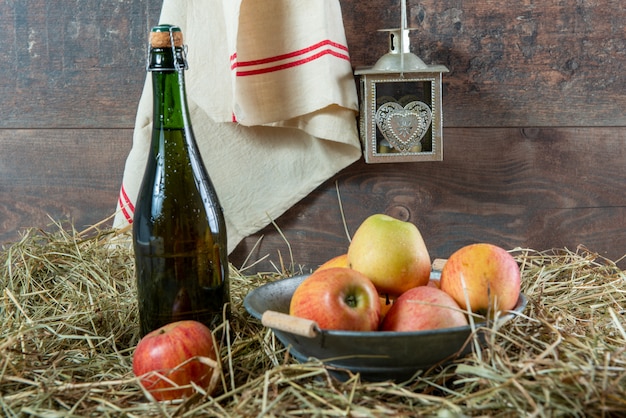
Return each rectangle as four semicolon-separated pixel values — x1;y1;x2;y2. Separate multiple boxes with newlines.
244;275;526;381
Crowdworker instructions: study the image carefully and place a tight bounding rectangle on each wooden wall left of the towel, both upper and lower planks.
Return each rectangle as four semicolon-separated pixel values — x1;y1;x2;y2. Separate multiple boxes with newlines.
0;0;161;238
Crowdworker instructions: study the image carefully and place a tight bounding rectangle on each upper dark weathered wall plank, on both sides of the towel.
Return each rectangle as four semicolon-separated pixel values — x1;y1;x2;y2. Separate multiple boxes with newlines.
0;0;626;128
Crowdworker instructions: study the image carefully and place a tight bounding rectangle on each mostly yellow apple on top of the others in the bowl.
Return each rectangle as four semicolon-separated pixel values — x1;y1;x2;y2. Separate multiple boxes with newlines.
348;213;431;297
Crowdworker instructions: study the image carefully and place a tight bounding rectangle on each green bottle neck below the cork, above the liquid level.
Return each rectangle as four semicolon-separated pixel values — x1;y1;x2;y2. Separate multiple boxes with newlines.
148;48;189;129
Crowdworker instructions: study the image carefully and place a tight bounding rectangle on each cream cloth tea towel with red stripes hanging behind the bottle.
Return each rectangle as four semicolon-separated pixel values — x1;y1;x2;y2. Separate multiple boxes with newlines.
114;0;361;253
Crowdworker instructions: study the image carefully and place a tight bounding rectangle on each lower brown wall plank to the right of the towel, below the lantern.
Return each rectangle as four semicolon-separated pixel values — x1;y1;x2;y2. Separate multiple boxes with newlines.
231;128;626;271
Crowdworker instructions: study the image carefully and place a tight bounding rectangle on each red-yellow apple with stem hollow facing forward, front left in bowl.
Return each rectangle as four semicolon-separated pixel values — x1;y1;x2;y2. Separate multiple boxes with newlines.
289;267;380;331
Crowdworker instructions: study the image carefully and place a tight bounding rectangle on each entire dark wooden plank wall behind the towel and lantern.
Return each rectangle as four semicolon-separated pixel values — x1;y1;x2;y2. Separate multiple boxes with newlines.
0;0;626;272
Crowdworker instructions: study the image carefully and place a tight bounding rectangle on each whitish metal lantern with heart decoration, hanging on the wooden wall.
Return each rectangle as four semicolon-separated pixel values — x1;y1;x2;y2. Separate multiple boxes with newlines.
355;0;448;163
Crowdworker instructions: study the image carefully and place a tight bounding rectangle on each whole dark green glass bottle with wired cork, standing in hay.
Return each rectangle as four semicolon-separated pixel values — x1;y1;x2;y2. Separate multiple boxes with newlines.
133;25;230;335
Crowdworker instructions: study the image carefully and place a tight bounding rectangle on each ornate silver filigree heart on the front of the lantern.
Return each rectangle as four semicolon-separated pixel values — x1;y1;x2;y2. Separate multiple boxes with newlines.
376;101;432;152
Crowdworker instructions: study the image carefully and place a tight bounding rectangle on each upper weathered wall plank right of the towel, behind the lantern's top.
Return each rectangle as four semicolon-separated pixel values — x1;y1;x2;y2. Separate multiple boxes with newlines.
342;0;626;127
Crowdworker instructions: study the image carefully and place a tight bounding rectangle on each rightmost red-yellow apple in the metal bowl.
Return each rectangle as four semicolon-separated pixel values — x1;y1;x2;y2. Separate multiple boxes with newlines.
439;243;521;316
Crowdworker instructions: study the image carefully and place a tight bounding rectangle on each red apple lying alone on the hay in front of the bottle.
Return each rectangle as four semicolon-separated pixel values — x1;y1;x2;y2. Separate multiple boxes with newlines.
133;320;216;401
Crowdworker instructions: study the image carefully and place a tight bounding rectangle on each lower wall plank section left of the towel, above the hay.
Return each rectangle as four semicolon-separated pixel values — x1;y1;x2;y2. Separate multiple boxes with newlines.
0;129;132;243
